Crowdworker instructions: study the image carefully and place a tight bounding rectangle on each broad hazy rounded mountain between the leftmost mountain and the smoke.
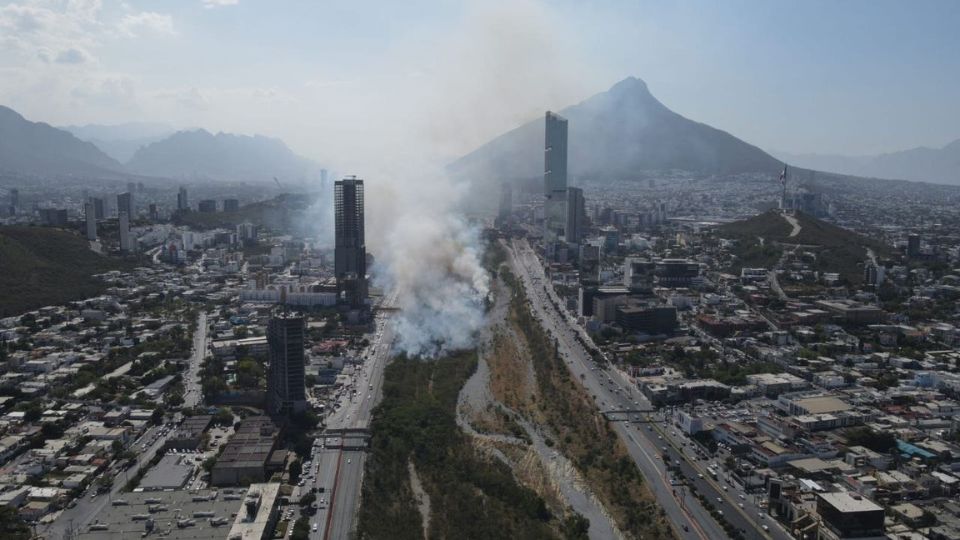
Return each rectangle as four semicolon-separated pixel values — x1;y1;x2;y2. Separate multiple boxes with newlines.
127;129;320;181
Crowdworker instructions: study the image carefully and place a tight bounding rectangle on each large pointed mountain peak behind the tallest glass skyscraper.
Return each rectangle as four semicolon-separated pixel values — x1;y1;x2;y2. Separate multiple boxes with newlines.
450;77;783;179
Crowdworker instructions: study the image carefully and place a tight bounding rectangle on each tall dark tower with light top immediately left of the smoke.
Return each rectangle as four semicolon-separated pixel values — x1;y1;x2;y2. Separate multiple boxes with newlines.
333;176;367;308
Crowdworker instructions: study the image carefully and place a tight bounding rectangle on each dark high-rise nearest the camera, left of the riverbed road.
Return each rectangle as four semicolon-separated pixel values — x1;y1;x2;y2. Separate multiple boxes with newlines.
267;313;307;415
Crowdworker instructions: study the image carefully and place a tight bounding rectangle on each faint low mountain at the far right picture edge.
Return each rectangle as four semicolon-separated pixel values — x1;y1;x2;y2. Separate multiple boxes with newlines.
776;139;960;185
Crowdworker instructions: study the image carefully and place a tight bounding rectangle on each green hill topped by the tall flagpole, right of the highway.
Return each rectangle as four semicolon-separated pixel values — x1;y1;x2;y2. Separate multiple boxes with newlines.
717;210;891;283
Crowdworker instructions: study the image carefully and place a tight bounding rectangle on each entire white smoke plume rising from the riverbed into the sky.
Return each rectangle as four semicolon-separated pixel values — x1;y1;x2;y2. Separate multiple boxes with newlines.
312;0;587;357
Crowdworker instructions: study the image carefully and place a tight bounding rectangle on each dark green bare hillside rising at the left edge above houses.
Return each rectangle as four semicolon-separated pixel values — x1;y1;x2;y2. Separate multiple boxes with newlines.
0;227;129;317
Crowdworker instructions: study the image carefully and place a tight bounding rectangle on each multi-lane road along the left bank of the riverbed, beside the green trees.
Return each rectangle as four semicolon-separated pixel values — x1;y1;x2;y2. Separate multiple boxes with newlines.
296;293;397;540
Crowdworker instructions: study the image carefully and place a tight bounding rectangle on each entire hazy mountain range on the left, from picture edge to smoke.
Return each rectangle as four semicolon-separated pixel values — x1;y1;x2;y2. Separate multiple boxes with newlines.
0;106;320;182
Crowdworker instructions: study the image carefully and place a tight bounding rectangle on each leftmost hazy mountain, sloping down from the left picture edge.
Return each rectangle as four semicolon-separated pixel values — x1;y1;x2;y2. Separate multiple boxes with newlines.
0;106;123;176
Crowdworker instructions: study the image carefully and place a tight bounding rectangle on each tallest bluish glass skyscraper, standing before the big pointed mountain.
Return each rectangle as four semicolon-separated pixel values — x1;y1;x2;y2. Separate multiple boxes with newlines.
543;111;567;242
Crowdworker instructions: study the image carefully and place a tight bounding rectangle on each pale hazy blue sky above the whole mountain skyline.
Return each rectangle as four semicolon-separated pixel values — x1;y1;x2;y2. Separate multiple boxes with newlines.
0;0;960;163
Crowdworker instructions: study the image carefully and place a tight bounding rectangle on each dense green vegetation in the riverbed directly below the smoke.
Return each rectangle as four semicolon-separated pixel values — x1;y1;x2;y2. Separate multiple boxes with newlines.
357;353;560;539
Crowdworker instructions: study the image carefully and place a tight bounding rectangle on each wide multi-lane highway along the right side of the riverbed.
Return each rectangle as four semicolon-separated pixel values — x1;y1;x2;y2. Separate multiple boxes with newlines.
510;241;788;540
